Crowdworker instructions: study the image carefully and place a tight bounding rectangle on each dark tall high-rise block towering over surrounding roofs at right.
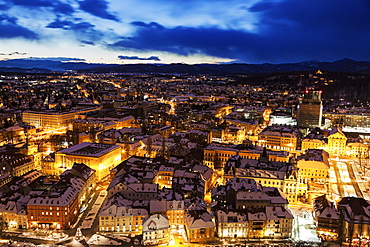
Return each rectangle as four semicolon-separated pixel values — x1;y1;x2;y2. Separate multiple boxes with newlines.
297;90;322;128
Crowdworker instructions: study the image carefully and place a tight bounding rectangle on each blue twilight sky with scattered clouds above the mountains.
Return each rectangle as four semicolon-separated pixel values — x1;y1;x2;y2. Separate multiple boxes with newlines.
0;0;370;63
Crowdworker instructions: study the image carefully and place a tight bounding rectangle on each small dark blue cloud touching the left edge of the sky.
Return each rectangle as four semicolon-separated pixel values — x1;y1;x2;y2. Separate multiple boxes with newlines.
0;14;38;39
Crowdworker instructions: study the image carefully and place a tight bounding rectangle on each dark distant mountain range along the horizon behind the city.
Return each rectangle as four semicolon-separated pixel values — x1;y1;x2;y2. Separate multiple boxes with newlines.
0;58;370;75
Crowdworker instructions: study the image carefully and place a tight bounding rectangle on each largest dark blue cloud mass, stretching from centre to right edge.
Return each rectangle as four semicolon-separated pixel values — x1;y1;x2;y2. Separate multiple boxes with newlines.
113;0;370;62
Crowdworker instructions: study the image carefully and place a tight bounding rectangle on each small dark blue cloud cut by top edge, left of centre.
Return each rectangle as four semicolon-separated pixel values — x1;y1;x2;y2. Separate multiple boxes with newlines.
79;0;118;21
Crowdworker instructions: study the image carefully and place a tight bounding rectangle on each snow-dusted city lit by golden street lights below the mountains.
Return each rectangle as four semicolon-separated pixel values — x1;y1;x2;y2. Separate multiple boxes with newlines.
0;70;370;247
